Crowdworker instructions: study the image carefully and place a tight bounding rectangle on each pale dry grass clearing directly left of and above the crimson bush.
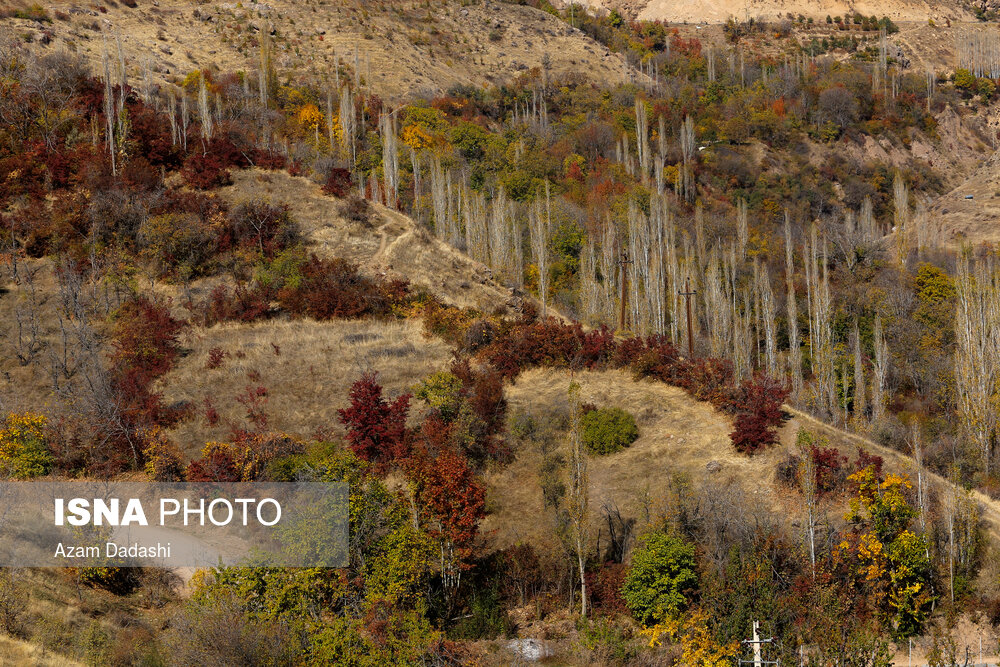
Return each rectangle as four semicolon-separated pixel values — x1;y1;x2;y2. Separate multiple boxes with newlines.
160;320;451;456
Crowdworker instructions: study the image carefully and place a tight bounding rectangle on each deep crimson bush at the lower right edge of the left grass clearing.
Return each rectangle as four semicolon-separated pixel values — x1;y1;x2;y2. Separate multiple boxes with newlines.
337;373;410;471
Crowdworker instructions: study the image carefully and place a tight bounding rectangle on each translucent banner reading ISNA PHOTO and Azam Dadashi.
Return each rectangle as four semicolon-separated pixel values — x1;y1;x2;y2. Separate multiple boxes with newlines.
0;482;348;567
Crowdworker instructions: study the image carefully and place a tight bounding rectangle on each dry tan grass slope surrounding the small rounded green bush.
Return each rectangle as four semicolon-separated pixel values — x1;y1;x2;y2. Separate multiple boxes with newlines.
484;370;782;546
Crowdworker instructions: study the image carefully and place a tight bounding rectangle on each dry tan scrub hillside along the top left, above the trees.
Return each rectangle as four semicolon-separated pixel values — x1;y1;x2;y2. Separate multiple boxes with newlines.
0;0;623;98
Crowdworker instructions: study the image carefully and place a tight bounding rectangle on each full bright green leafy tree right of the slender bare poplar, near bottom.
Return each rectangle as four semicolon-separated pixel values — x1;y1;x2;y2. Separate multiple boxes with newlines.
622;533;698;626
